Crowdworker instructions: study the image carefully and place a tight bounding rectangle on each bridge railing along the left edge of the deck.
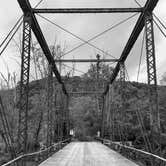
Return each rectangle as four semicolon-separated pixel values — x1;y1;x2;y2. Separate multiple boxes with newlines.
2;139;70;166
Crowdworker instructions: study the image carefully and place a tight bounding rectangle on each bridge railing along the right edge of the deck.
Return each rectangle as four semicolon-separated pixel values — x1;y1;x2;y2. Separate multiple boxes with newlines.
98;138;166;166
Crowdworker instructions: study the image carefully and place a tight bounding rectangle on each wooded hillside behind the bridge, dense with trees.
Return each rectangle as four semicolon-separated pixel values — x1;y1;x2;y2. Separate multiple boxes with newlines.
0;70;166;163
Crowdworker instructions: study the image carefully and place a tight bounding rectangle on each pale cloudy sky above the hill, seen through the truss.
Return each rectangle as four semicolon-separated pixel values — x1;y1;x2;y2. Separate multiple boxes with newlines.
0;0;166;87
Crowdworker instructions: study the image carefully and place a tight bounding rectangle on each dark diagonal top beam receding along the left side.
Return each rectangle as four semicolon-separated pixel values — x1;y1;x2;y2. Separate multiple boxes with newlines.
17;0;67;94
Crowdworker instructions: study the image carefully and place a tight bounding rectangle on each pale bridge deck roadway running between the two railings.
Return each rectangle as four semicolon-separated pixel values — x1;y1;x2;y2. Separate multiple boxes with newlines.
40;142;138;166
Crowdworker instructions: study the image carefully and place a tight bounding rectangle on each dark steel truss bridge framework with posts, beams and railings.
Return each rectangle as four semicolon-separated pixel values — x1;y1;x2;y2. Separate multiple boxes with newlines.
0;0;166;166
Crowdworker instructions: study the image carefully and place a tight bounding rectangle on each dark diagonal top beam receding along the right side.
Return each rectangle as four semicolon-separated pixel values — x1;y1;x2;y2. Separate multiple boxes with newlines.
104;0;159;94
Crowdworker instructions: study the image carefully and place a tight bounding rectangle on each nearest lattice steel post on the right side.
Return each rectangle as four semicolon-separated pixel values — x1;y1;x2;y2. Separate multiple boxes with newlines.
145;13;160;150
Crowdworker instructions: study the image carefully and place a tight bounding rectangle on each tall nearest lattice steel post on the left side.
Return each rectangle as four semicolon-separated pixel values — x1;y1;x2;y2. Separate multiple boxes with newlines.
18;14;31;153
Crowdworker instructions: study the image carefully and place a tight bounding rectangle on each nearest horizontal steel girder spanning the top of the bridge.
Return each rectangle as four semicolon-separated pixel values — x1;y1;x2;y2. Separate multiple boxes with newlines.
33;8;143;14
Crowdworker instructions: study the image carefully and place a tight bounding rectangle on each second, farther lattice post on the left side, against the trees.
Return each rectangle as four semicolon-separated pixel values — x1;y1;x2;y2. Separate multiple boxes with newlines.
47;65;53;147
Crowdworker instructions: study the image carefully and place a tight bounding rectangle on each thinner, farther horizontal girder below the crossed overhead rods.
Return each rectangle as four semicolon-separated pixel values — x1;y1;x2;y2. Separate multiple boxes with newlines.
55;59;118;63
